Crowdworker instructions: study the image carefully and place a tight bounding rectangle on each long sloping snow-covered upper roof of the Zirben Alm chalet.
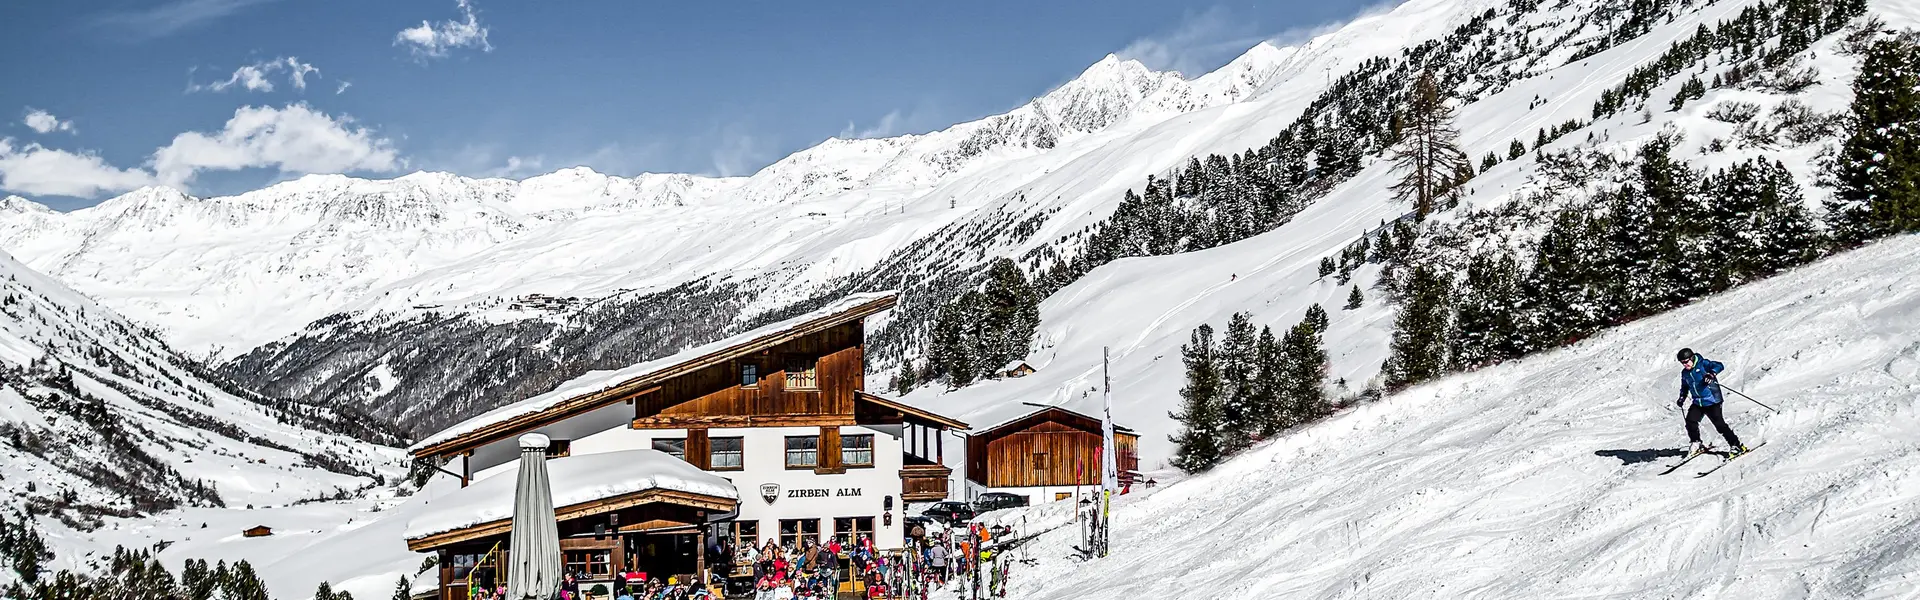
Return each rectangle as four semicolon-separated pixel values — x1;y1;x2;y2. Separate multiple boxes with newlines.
407;292;897;454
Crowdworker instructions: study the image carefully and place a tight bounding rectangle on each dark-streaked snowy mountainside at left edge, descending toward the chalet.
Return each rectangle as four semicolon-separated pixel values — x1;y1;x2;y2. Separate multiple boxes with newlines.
0;254;405;531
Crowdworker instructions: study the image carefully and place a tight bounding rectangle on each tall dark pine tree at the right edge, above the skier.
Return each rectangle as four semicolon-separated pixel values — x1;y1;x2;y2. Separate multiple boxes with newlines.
1826;37;1920;246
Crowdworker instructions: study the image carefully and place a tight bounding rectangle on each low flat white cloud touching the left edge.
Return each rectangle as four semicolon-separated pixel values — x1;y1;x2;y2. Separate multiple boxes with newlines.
0;138;154;198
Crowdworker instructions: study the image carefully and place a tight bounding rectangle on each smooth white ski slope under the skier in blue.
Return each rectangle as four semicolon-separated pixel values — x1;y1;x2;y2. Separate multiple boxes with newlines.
995;235;1920;600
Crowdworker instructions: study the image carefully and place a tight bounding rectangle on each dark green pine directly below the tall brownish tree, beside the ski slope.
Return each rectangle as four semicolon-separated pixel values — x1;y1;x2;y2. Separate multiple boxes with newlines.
1386;267;1452;387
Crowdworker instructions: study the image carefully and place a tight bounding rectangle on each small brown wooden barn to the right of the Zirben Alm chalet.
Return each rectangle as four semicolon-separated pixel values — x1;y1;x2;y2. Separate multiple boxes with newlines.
966;406;1140;502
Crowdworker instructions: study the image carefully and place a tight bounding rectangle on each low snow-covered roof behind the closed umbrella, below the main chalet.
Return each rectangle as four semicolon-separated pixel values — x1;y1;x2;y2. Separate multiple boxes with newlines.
405;450;739;540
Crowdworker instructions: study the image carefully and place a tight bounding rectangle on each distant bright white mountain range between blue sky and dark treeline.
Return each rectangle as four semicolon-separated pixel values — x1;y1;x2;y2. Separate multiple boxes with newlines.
0;44;1286;356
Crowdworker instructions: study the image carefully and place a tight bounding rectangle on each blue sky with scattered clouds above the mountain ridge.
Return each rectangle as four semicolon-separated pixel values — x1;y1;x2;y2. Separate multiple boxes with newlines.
0;0;1367;210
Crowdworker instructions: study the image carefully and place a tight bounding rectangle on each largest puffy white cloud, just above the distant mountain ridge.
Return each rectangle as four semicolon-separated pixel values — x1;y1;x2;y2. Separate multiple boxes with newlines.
152;104;403;187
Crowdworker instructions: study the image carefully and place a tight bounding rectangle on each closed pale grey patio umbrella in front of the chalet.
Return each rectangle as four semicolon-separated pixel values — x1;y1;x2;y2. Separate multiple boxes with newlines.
507;433;561;600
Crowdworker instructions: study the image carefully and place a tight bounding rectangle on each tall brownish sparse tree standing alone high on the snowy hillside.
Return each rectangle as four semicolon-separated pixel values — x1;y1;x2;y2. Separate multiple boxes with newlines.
1392;71;1473;219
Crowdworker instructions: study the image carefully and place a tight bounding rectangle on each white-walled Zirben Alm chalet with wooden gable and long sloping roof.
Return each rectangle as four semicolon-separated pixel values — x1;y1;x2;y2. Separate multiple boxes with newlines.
411;294;968;600
